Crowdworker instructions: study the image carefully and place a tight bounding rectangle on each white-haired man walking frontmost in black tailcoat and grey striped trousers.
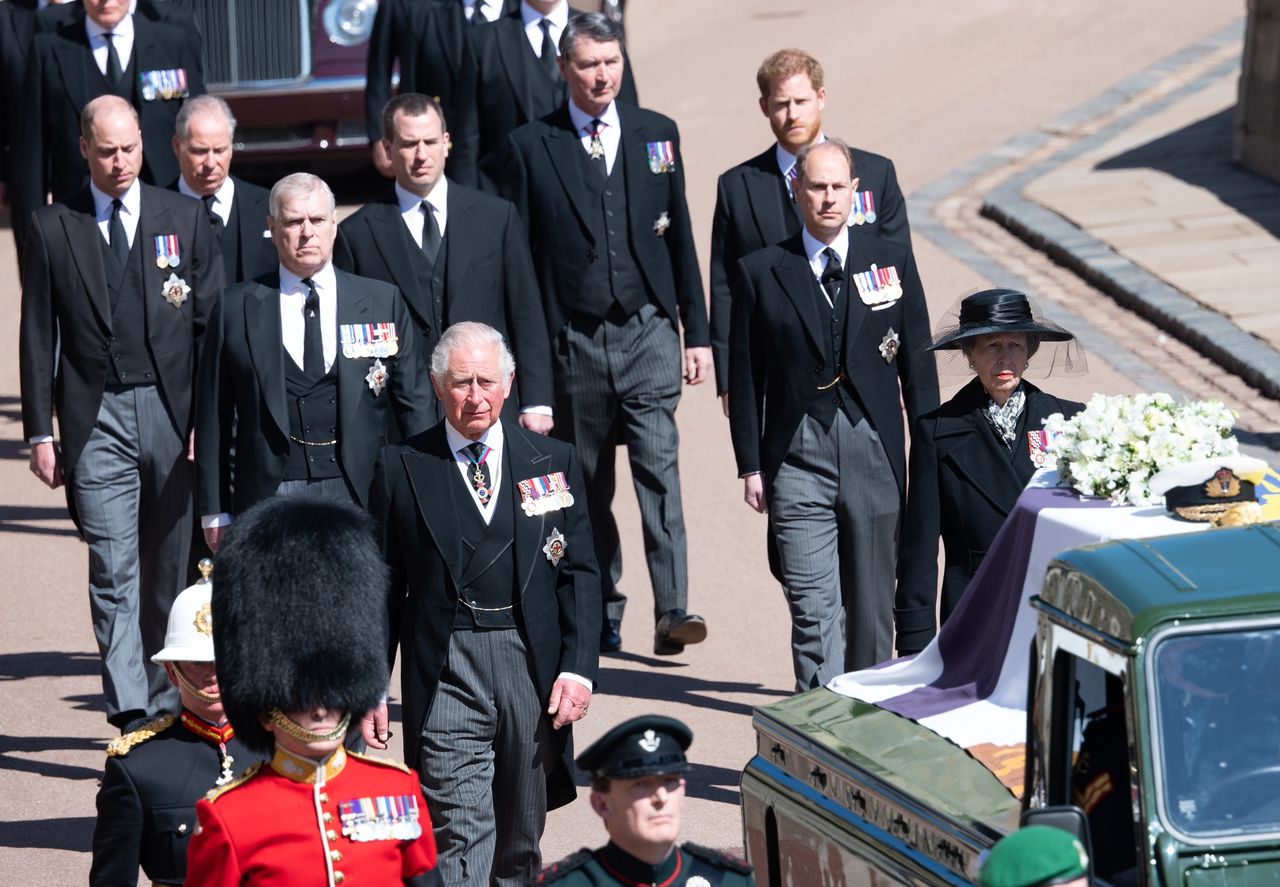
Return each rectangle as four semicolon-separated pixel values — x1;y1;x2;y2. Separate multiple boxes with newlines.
364;321;600;884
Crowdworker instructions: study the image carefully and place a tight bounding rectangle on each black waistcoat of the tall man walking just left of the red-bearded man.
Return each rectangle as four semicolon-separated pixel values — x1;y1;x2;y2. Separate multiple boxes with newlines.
576;145;649;317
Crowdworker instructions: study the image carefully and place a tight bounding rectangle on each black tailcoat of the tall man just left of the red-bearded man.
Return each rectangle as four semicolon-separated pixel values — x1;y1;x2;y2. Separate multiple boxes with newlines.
503;102;710;348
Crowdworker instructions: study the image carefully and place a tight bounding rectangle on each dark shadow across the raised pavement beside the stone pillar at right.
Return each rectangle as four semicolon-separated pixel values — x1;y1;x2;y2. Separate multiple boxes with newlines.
1097;106;1280;237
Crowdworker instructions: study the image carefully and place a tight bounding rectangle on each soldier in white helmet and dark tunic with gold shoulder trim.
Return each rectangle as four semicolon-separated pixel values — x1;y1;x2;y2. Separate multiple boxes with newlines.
90;559;259;887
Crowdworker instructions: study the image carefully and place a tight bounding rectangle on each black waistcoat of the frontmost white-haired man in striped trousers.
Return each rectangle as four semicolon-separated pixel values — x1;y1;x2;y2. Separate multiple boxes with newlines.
452;448;516;628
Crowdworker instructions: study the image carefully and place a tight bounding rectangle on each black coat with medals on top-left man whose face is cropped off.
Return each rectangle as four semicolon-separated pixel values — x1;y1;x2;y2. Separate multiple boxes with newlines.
13;5;205;249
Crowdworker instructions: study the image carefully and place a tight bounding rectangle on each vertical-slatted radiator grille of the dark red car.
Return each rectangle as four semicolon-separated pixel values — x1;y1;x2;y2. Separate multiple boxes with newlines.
170;0;311;87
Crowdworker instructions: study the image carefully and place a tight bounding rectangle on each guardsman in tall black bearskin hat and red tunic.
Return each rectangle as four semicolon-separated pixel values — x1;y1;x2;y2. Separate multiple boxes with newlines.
187;498;439;887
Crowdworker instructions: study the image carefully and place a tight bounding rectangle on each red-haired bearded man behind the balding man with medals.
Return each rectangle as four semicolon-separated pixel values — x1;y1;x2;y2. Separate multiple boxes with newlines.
710;49;911;413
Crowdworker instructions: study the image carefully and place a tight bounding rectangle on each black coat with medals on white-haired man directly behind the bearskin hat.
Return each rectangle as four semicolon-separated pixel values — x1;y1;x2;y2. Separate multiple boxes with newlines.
194;266;435;515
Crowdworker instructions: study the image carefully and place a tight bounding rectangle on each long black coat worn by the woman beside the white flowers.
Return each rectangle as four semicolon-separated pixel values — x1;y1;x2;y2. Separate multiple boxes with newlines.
895;376;1084;651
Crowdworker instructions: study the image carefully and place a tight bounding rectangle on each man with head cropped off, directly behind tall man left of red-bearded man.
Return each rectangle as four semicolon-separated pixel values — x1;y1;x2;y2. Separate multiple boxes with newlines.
449;0;640;191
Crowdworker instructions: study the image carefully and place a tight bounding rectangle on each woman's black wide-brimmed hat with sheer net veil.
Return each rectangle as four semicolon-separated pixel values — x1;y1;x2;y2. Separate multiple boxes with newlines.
925;288;1088;378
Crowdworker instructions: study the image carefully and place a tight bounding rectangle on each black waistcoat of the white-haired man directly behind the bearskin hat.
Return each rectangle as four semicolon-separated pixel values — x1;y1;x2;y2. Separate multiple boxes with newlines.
280;346;342;480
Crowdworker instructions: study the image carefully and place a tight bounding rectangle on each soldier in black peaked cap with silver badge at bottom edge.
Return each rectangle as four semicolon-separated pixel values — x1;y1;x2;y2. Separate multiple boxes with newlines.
535;714;755;887
